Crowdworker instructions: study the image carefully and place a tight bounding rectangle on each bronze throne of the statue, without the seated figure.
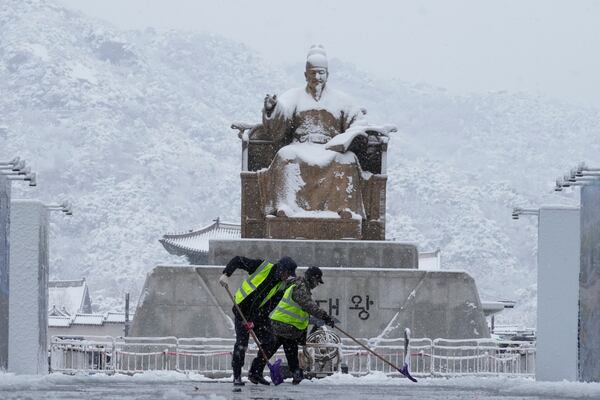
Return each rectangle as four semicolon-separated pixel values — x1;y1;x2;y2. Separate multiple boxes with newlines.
231;123;395;240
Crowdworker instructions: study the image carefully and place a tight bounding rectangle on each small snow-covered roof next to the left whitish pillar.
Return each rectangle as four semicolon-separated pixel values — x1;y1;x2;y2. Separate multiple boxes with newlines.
48;278;92;315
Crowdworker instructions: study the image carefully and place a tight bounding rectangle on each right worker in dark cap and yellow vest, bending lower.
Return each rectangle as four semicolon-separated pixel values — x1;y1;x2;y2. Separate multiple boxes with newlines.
249;267;334;385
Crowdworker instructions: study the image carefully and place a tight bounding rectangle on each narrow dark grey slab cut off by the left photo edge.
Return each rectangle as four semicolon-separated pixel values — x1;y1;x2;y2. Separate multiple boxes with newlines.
0;175;10;371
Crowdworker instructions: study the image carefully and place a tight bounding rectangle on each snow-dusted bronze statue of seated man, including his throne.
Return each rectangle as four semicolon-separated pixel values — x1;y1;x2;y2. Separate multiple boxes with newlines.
233;45;395;239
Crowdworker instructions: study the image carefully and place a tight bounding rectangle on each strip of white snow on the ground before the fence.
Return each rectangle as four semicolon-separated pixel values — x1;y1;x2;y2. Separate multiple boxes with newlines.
0;371;600;399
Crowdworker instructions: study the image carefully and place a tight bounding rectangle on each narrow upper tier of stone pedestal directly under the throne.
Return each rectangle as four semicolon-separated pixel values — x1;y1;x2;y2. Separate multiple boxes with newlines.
208;239;419;269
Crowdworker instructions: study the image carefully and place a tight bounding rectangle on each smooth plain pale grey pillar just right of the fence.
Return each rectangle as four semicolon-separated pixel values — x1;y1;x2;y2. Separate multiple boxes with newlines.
535;207;581;381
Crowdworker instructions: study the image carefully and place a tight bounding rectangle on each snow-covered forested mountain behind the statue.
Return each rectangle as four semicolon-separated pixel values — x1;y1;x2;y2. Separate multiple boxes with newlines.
0;0;600;325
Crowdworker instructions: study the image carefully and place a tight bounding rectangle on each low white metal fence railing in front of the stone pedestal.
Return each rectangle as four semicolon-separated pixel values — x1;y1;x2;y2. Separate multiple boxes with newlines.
50;336;535;377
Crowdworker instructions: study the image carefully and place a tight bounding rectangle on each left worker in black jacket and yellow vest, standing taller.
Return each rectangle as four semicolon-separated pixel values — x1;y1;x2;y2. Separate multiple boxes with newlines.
219;256;297;386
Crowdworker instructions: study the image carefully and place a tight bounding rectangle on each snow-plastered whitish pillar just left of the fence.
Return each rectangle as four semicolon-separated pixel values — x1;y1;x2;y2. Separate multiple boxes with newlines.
8;200;48;374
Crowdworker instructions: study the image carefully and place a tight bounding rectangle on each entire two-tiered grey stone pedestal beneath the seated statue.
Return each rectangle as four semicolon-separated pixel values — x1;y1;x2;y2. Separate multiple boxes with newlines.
139;239;489;339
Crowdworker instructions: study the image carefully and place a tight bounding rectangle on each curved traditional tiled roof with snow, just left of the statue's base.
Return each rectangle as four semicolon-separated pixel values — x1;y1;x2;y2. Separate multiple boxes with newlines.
159;218;241;256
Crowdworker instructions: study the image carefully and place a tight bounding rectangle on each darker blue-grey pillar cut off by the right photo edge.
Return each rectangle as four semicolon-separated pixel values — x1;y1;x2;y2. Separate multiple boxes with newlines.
576;183;600;382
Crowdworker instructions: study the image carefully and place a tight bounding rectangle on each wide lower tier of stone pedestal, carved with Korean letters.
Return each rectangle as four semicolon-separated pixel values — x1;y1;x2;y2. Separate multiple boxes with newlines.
131;266;489;339
